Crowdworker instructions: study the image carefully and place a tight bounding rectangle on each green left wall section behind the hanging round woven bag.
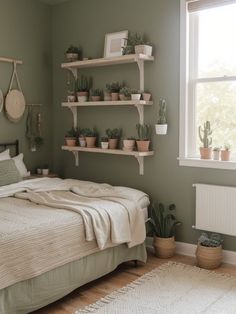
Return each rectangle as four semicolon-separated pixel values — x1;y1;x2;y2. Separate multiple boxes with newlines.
0;0;52;170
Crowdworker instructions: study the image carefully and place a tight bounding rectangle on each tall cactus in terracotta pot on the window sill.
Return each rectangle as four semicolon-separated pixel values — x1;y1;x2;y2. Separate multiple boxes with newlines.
198;121;212;159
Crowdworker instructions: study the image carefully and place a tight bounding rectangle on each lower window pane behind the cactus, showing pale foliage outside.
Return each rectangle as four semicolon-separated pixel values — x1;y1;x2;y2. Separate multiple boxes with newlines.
196;82;236;155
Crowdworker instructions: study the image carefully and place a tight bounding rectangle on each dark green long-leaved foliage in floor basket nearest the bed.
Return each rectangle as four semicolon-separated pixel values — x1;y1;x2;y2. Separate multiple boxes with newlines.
147;203;181;238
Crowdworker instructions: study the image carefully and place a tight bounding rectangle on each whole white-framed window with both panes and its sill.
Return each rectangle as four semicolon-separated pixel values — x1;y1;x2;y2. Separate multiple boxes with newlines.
180;0;236;169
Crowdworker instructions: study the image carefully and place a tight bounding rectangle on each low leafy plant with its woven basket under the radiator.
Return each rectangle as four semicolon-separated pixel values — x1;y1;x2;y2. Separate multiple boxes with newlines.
196;232;223;269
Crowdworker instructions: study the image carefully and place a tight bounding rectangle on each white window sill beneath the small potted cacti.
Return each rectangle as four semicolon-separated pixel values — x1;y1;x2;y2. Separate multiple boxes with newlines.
178;157;236;170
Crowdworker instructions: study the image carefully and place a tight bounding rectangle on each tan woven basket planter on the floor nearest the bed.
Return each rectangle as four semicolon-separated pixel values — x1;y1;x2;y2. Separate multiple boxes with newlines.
153;236;176;258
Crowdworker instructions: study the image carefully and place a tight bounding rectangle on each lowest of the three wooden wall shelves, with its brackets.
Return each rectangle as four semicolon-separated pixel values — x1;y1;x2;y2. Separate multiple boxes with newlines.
62;146;154;175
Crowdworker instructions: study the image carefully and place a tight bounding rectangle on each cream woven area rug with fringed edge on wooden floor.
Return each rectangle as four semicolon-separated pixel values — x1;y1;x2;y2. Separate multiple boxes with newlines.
75;262;236;314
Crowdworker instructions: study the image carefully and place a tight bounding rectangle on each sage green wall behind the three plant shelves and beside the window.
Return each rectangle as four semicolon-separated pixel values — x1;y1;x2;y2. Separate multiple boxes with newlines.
52;0;236;250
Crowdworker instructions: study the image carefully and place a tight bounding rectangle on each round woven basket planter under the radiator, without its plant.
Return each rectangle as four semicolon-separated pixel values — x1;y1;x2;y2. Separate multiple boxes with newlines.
196;244;223;269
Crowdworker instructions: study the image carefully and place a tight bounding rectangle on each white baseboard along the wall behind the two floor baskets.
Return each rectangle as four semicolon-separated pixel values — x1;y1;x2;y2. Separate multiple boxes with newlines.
146;237;236;265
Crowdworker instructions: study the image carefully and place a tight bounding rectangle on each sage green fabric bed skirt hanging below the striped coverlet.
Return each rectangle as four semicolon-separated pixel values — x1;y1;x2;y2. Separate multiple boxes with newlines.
0;244;147;314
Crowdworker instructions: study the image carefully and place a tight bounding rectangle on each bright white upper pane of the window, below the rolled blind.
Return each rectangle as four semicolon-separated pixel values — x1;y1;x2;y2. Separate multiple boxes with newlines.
198;4;236;77
